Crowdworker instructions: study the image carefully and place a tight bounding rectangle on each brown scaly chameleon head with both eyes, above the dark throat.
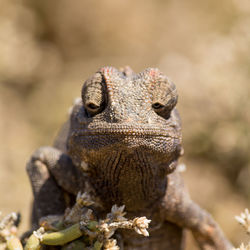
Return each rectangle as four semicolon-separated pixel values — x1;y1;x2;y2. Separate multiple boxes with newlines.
68;67;182;172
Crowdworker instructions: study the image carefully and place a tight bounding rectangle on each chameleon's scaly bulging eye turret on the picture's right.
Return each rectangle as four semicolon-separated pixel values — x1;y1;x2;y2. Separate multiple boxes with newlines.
152;78;178;119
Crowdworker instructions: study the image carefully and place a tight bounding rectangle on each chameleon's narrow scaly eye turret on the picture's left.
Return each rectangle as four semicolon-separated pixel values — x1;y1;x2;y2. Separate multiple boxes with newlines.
82;73;106;117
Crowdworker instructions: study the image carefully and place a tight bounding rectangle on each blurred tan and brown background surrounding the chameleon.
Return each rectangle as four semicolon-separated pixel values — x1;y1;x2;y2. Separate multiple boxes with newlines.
0;0;250;249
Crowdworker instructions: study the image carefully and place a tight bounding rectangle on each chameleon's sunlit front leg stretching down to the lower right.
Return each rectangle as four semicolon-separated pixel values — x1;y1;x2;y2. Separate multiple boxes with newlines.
163;173;233;250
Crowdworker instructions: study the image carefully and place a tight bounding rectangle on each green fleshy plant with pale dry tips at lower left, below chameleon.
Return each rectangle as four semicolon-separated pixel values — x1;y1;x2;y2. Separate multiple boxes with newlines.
0;194;150;250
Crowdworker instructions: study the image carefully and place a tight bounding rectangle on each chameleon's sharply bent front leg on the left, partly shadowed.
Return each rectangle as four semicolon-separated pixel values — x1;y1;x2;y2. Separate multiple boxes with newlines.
27;147;85;224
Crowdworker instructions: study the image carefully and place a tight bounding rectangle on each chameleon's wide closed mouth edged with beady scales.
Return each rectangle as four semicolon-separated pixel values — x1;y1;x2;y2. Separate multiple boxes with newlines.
73;124;179;139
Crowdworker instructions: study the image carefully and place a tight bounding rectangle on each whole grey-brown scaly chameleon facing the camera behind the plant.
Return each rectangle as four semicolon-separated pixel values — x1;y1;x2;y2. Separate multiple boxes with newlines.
27;67;231;250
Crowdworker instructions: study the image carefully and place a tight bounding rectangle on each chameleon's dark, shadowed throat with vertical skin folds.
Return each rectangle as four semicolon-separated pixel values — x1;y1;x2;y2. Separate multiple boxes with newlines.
90;150;166;211
